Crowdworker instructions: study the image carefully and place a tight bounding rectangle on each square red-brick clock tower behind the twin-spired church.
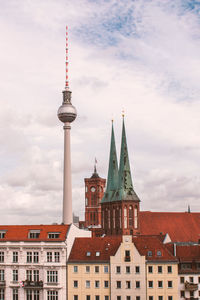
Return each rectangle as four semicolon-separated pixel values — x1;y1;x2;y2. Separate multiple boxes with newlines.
84;165;106;227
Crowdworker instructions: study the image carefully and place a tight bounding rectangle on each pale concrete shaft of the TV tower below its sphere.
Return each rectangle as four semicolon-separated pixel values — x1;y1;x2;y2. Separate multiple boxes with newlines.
63;122;73;224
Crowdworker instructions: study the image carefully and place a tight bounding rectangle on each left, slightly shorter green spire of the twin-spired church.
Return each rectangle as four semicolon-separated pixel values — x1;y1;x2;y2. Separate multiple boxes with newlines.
101;121;118;203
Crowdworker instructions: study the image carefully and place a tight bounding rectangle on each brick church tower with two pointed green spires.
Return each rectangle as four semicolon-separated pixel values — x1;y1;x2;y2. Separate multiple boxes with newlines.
101;117;140;235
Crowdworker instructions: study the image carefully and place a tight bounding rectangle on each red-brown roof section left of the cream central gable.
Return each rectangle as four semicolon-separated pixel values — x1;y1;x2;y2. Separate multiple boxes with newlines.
69;236;122;262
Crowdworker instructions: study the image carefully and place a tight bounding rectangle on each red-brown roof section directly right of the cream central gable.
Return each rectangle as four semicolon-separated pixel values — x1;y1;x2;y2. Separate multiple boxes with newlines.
133;235;176;261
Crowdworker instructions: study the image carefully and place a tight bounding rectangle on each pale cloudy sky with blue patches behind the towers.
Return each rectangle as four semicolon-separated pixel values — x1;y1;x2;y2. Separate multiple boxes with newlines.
0;0;200;224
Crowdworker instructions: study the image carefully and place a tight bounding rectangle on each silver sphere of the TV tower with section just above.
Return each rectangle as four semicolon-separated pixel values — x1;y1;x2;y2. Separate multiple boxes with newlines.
58;90;77;123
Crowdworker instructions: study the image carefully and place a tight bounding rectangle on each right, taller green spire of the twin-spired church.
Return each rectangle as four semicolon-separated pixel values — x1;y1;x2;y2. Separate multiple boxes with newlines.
115;116;140;201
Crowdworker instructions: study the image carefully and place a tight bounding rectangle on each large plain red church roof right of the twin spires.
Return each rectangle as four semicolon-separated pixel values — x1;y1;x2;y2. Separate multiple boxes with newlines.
140;211;200;242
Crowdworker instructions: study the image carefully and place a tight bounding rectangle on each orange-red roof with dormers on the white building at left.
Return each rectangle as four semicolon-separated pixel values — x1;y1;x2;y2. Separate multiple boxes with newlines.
0;225;70;242
